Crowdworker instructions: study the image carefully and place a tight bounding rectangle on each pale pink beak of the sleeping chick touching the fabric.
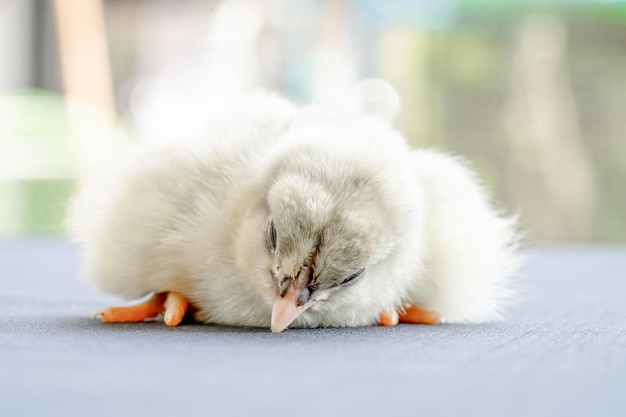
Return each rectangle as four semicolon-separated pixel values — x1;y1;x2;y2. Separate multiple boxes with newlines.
272;278;310;333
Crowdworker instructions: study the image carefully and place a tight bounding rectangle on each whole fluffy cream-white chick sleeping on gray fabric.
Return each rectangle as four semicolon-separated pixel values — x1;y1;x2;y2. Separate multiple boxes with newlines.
68;95;518;332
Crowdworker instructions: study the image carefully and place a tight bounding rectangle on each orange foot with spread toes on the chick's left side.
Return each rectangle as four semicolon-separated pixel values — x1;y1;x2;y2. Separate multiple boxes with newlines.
94;291;189;326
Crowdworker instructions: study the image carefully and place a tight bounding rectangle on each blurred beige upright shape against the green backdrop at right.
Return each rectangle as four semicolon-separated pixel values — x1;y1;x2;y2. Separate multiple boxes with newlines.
505;15;595;243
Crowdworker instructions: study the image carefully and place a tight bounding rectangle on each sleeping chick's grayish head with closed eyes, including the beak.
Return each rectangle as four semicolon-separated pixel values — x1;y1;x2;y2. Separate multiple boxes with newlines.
264;150;393;332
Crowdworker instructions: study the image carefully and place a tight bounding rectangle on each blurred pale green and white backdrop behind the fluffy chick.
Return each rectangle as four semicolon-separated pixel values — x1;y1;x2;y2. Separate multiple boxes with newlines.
0;0;626;244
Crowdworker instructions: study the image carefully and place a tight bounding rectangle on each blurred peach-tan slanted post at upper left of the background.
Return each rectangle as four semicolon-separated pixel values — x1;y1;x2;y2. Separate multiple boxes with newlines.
54;0;115;117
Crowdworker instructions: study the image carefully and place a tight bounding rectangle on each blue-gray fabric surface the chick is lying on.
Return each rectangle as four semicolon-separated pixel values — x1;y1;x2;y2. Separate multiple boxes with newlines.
0;240;626;417
